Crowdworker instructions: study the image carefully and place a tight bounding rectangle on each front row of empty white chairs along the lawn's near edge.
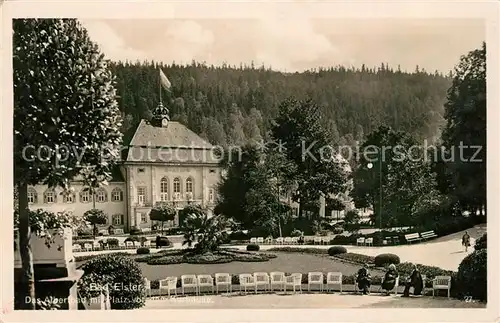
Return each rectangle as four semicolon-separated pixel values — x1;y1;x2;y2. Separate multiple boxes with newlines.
144;271;342;296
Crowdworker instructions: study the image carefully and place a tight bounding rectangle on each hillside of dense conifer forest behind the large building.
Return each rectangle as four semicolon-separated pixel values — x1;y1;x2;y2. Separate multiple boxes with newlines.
112;62;451;145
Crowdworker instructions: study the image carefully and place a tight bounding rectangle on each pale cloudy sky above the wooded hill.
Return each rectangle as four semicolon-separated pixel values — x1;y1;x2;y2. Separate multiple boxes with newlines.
81;18;485;73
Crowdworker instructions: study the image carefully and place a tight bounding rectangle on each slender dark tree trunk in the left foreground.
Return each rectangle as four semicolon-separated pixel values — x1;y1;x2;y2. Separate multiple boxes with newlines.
19;183;36;310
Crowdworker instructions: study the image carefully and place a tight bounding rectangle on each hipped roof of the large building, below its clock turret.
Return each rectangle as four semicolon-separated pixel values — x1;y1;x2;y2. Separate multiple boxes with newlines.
126;120;217;163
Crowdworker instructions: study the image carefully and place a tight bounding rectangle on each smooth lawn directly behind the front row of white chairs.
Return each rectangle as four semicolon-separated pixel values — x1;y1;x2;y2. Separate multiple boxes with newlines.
135;252;383;280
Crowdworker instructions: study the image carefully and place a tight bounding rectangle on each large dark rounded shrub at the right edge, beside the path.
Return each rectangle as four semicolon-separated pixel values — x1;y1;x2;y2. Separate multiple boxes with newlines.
457;249;488;301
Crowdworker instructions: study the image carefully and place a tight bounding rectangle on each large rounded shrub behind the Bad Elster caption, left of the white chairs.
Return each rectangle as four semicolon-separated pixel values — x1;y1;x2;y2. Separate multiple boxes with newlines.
78;255;146;309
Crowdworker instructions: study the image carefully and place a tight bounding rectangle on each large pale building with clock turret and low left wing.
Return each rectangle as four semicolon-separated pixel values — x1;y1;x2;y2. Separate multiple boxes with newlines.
28;104;222;231
